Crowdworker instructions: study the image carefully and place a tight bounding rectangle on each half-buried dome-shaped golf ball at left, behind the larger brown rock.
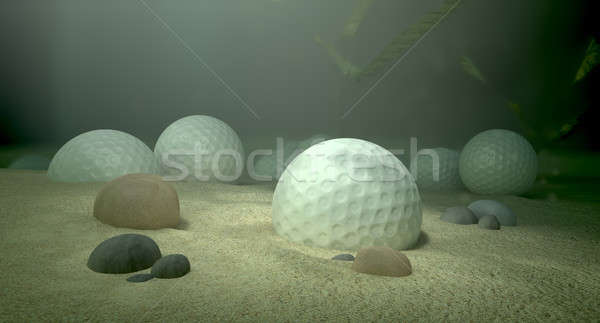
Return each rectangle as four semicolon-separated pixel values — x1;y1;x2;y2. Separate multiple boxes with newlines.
48;129;158;182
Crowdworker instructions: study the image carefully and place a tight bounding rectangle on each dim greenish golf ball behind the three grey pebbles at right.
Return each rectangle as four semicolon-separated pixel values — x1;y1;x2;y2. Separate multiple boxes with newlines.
459;129;537;194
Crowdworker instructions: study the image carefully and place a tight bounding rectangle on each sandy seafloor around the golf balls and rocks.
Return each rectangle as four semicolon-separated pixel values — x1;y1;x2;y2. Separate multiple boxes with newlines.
0;169;600;322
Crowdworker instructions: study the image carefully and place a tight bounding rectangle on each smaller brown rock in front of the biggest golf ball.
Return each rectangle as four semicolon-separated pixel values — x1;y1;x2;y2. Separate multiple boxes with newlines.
352;246;412;277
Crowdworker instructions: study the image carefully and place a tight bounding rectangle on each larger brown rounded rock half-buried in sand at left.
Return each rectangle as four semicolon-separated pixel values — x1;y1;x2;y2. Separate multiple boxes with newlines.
94;174;179;229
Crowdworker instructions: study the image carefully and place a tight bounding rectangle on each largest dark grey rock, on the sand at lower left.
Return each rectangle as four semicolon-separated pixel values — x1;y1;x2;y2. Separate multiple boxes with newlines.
87;233;161;274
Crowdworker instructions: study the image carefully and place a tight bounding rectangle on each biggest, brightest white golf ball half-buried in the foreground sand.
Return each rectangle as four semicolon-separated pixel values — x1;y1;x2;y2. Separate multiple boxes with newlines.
272;138;422;250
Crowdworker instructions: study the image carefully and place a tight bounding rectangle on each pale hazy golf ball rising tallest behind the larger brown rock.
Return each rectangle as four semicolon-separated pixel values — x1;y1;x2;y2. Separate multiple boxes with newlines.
154;115;245;182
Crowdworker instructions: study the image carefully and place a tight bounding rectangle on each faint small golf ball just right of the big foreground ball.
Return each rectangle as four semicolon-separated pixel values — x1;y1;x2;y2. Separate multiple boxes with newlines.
411;147;463;190
